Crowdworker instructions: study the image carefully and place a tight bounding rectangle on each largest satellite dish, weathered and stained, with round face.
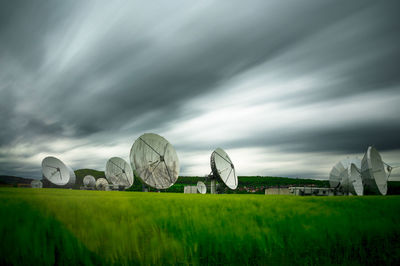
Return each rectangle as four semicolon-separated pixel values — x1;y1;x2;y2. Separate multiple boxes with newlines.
130;133;179;189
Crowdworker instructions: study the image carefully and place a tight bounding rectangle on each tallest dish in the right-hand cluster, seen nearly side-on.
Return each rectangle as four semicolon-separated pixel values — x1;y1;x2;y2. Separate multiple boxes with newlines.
361;146;388;195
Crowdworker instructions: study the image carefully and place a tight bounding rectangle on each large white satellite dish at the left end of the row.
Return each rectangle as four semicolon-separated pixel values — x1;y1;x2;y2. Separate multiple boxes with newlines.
42;156;76;187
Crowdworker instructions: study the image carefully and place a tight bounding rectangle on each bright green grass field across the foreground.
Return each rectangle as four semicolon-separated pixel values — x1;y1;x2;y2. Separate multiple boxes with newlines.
0;188;400;265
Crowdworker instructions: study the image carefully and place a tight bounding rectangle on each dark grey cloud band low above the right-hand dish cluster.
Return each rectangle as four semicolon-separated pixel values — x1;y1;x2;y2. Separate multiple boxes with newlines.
225;122;400;154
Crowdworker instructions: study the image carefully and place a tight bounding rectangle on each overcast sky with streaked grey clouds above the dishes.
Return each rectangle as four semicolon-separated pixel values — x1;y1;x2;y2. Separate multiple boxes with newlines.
0;0;400;179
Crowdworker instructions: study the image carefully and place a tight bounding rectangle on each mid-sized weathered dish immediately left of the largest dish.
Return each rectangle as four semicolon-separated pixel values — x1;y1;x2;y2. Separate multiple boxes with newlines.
105;157;134;188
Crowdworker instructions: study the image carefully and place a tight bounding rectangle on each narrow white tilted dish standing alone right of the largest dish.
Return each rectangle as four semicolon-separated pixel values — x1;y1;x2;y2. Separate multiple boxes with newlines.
211;148;238;189
